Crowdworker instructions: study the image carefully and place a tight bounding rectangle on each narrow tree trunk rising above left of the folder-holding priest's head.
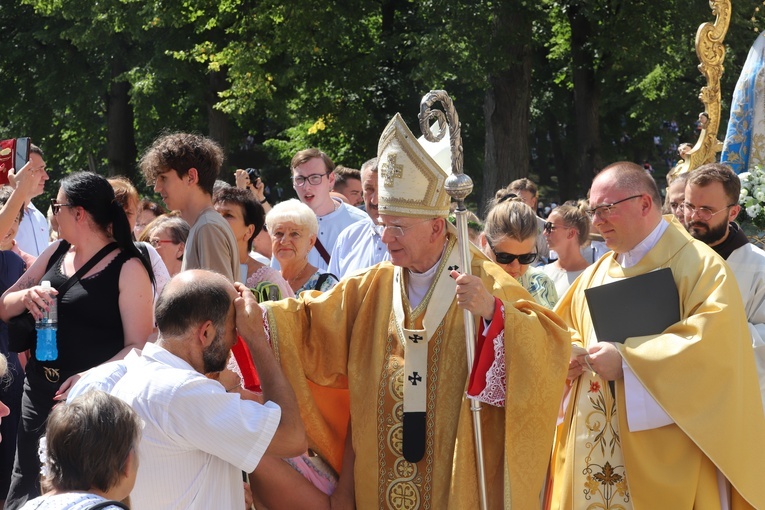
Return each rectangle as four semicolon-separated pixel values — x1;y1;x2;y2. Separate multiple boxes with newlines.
566;3;603;190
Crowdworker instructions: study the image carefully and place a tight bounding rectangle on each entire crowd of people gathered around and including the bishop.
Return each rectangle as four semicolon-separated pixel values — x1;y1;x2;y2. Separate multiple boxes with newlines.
0;109;765;510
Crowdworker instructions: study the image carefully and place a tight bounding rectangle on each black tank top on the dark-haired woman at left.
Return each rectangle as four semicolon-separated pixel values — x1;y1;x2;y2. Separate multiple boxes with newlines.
32;243;131;372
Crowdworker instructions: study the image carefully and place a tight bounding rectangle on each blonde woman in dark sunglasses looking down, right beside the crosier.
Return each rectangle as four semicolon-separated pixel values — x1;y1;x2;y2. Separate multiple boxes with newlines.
481;189;558;308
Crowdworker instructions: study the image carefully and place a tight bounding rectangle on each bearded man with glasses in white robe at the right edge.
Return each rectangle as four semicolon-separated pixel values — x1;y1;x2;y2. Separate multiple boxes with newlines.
683;163;765;406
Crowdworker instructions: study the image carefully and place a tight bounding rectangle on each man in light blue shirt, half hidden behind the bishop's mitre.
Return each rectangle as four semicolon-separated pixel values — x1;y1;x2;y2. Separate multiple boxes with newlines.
329;158;390;278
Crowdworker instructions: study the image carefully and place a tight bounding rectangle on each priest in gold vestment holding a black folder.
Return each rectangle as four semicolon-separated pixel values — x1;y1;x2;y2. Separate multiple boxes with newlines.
547;162;765;510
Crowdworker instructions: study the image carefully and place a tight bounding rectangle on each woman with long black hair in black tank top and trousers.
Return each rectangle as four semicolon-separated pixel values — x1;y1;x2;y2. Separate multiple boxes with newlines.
0;172;154;508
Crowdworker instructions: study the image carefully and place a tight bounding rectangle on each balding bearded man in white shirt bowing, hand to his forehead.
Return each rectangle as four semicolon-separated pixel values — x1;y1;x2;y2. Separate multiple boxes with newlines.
69;270;307;510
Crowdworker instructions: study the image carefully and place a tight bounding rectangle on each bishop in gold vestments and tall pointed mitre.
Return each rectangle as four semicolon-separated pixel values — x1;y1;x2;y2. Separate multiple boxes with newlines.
265;115;571;510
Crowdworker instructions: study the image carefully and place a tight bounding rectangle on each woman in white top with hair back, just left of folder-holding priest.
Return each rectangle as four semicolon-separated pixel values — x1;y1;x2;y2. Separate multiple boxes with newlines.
542;200;590;296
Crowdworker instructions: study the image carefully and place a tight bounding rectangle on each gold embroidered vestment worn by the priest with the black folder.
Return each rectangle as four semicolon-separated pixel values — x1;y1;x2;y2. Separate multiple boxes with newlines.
551;217;765;510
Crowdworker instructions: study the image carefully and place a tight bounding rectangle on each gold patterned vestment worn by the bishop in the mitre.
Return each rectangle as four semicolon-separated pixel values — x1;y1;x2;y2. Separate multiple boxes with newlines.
266;241;570;510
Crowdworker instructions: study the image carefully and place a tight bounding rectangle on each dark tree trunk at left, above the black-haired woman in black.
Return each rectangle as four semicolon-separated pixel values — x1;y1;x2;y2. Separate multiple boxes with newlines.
106;55;138;183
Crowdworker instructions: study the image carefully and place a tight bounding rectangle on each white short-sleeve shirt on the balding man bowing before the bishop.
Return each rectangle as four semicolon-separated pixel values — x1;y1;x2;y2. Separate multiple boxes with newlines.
70;343;281;510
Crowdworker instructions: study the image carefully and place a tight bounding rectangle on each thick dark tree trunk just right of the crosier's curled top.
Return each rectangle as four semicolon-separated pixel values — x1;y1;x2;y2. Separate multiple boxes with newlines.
479;5;532;210
